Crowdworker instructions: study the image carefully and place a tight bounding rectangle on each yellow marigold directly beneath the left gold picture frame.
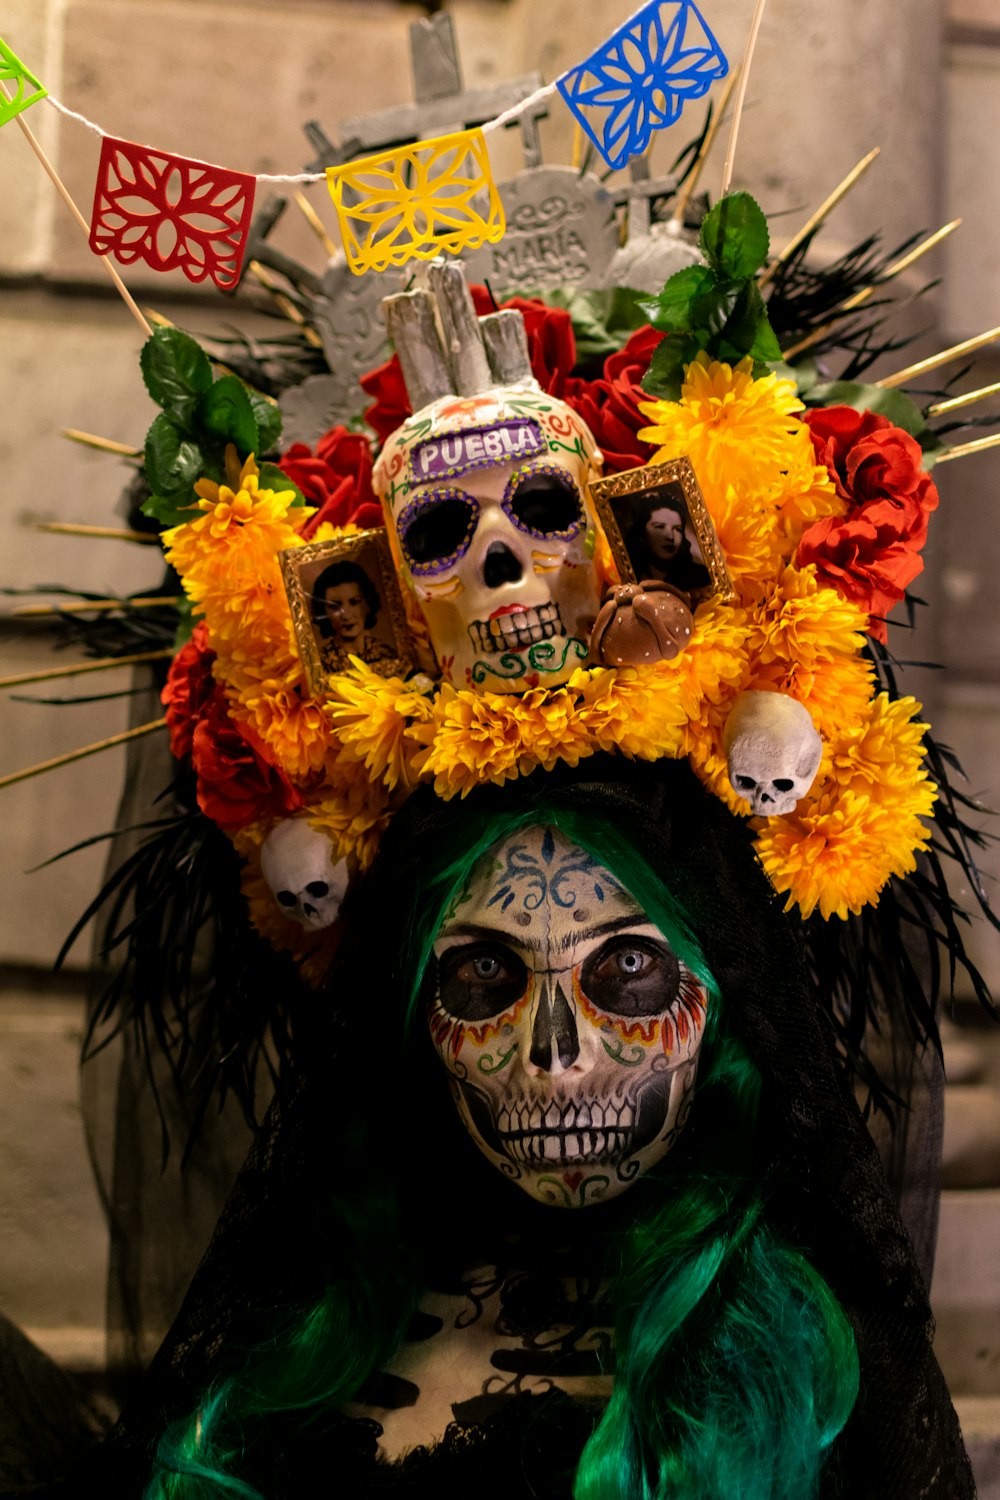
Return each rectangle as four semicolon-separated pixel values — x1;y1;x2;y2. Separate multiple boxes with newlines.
325;657;432;792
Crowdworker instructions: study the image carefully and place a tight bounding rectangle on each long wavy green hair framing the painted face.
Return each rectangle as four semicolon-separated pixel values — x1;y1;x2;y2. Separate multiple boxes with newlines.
145;803;858;1500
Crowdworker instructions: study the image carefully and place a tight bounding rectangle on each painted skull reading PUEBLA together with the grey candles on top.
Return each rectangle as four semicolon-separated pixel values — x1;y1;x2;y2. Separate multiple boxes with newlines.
373;263;603;693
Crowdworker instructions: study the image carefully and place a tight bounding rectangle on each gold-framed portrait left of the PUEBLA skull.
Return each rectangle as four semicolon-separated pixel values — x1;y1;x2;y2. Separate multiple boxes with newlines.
279;527;414;698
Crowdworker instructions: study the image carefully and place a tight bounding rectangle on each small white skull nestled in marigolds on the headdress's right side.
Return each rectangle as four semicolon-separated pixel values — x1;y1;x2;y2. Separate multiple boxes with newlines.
724;690;823;818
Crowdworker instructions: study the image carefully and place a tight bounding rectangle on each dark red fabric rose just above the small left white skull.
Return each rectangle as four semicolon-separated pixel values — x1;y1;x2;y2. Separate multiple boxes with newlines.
190;686;301;833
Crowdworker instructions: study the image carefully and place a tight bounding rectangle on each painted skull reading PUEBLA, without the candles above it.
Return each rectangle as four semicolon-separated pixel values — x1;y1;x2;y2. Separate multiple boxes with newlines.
375;386;601;693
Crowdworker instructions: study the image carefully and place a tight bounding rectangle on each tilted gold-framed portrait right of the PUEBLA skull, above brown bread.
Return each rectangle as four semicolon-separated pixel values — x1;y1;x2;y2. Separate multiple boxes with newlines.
589;459;736;605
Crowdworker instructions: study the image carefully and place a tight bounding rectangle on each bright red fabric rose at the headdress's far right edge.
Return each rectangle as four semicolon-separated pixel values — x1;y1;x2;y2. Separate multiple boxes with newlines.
796;407;939;641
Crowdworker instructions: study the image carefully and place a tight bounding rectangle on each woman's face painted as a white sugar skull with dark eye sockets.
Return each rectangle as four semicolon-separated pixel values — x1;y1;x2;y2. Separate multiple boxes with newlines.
429;828;708;1208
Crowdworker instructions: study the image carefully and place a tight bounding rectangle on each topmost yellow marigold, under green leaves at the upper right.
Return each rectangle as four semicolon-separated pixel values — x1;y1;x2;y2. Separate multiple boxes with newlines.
639;353;811;495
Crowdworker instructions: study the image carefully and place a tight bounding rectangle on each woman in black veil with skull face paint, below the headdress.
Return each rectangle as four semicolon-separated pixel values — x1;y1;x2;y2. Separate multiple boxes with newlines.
89;758;973;1500
